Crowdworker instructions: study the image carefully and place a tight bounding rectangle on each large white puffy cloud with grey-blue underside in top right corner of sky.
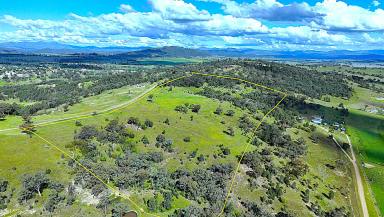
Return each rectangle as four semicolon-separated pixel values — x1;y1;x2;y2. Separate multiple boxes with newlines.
210;0;384;32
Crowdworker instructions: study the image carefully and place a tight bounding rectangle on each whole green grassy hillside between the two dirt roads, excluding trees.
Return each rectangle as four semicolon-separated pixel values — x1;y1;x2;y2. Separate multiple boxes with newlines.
0;82;355;216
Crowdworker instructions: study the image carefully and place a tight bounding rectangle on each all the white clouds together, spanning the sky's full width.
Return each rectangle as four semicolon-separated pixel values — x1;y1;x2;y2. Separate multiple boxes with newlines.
0;0;378;49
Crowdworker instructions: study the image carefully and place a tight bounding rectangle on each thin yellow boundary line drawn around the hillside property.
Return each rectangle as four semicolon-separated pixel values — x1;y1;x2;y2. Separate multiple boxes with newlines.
21;72;287;217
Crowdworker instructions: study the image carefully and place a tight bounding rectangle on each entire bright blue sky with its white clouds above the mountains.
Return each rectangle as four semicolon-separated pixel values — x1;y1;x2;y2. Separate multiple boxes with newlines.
0;0;384;50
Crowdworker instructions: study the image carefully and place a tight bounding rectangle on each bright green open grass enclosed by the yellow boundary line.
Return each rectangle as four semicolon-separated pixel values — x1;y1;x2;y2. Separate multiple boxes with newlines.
29;88;255;216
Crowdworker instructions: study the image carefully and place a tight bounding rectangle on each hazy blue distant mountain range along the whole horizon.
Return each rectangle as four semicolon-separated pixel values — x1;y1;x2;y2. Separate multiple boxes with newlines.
0;42;384;61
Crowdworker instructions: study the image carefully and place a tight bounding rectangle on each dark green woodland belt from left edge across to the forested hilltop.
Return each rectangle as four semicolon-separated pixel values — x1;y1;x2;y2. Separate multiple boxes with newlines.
0;59;352;115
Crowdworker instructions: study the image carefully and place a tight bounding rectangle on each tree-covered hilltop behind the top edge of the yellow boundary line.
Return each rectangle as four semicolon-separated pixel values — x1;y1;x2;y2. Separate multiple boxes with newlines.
172;59;352;99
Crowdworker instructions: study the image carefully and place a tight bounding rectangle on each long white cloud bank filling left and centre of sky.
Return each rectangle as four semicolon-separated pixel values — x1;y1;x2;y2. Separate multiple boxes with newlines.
1;0;268;38
